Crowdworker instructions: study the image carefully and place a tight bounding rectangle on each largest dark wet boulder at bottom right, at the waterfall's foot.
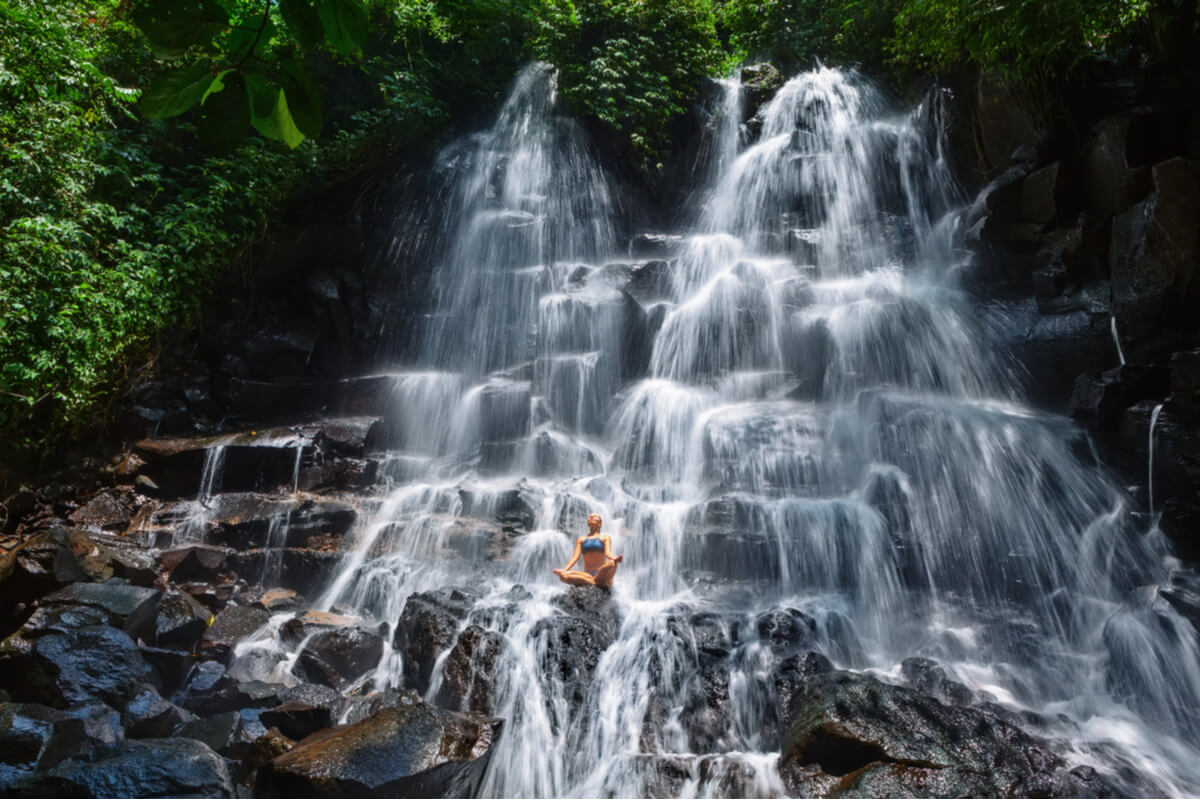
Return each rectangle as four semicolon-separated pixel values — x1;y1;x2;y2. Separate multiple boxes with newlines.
780;672;1112;796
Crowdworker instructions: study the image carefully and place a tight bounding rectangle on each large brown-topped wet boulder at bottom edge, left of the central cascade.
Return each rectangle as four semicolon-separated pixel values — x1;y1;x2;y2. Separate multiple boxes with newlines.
254;703;500;798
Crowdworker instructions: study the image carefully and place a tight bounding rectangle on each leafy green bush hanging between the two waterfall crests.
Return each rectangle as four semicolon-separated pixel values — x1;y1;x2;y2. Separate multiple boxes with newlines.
534;0;724;167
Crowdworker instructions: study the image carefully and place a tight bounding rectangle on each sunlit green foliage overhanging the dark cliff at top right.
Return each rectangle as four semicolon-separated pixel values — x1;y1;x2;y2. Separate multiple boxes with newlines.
889;0;1150;83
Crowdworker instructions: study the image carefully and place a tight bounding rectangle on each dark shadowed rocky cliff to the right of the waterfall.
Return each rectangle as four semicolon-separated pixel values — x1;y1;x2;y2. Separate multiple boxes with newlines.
959;67;1200;558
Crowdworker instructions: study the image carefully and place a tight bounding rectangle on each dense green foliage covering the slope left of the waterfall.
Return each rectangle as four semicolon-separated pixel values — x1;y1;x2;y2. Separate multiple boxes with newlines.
0;0;517;465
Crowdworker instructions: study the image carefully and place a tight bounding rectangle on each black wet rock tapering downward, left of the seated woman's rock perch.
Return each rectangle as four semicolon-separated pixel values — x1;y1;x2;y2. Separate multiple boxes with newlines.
392;589;475;693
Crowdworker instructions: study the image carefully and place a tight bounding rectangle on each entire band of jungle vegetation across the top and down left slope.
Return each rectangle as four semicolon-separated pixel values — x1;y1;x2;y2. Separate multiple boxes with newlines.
0;0;1171;464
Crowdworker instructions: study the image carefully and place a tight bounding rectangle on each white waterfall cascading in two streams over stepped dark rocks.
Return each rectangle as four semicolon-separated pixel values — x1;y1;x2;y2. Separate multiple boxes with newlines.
231;66;1200;796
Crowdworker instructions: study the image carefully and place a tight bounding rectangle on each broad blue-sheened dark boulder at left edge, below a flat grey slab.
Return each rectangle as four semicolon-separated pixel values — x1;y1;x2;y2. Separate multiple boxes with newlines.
0;625;151;708
